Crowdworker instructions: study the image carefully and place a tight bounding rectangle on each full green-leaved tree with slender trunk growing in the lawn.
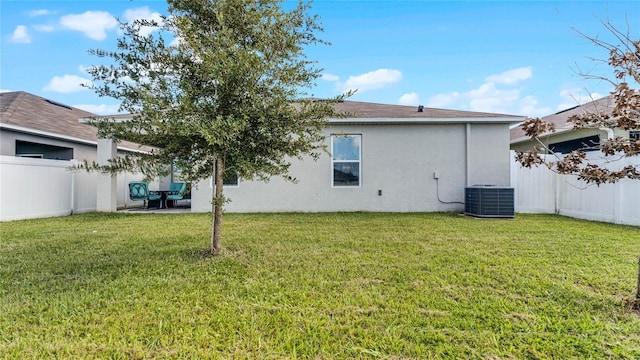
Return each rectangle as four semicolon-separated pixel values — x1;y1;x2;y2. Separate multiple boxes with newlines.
85;0;343;253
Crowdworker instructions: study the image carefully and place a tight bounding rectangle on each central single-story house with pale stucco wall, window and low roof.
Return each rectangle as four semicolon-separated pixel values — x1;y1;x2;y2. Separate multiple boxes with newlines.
191;101;524;212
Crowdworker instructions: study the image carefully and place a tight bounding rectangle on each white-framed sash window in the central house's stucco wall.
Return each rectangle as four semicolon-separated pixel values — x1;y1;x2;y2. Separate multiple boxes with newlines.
331;135;362;187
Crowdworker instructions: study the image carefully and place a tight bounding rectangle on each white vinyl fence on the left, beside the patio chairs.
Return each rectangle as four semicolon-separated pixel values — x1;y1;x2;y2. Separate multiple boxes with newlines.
0;156;148;221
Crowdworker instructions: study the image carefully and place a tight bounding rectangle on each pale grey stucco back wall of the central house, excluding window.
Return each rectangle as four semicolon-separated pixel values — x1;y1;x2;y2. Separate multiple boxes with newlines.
191;124;510;212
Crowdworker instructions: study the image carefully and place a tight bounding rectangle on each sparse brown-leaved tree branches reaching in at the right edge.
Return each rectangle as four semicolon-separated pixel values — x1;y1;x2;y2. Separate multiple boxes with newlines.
516;22;640;185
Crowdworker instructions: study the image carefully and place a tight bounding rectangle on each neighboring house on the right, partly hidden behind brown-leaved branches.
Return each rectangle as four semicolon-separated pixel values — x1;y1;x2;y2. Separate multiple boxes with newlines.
510;95;640;154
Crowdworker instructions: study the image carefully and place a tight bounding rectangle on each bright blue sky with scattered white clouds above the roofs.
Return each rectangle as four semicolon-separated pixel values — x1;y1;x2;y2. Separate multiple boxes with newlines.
0;0;640;116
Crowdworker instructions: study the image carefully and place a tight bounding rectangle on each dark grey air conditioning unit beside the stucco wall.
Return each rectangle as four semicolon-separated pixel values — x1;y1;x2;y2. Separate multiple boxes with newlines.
464;185;515;218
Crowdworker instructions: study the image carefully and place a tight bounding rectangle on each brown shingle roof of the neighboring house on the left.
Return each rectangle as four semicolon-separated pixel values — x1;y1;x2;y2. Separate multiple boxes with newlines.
0;91;141;150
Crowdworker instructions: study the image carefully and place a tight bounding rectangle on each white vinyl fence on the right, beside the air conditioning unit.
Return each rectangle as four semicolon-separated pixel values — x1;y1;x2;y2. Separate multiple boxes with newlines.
511;153;640;226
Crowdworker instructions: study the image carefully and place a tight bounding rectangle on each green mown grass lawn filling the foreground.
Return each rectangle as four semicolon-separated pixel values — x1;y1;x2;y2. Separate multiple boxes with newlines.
0;213;640;359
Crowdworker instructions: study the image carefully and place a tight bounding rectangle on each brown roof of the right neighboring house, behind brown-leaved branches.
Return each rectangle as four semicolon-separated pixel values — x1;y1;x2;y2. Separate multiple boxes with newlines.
510;95;615;144
